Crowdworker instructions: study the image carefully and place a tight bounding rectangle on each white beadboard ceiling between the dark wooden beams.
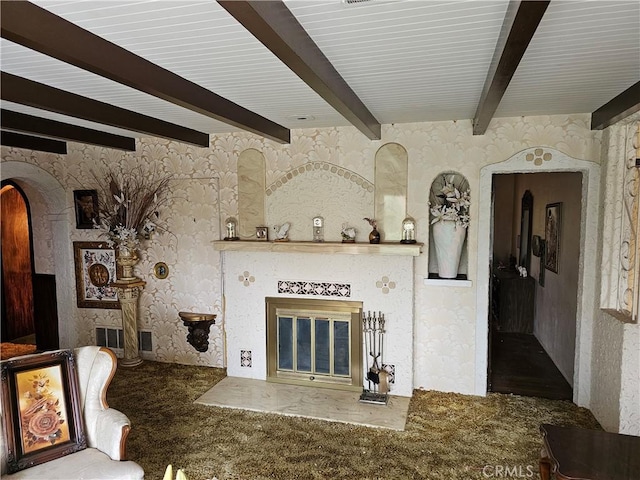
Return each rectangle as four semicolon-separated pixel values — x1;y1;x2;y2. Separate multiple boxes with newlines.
0;0;640;141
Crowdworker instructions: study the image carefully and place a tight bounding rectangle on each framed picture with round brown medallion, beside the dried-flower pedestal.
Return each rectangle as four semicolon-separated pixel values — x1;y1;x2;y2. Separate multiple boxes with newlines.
73;242;120;308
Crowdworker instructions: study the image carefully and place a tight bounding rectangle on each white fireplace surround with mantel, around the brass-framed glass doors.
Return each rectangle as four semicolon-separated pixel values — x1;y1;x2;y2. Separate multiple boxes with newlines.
215;241;419;396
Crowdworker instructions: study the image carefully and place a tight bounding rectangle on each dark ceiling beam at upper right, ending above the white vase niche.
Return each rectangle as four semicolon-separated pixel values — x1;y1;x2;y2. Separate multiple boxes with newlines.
473;0;550;135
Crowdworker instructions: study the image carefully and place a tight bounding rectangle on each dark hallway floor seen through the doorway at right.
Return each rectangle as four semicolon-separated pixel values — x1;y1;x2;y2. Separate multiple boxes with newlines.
489;332;573;400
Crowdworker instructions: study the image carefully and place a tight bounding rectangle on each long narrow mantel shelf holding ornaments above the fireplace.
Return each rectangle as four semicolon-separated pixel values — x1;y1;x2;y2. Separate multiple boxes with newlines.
213;240;423;257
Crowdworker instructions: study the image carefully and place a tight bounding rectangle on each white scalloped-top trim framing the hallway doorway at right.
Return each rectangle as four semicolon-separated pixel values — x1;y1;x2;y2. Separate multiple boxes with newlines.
475;147;600;406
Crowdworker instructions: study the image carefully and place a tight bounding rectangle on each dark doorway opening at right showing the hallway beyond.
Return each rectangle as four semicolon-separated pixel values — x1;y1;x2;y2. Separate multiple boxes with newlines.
488;172;583;400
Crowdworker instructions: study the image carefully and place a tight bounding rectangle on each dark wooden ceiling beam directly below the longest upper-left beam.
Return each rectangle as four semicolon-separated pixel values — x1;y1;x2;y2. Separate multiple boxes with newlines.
0;72;209;147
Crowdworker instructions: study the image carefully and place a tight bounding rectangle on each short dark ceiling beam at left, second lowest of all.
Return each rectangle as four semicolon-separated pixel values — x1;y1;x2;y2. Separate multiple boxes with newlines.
0;108;136;152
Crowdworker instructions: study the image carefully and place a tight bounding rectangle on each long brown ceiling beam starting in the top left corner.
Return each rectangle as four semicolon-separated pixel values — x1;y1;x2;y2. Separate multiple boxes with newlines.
0;1;291;143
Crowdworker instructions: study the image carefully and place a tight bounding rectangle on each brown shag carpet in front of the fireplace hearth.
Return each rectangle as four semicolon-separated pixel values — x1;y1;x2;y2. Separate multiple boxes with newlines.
108;361;599;480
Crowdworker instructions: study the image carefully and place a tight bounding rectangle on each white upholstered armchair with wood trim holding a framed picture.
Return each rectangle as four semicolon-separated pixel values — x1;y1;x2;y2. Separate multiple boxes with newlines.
0;346;144;480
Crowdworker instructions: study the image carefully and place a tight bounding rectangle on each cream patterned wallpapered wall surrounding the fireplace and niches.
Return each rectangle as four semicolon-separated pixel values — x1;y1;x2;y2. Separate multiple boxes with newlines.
8;115;636;416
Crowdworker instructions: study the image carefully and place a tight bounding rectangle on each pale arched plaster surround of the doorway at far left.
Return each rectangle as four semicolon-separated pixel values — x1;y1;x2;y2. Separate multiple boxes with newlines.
1;161;76;348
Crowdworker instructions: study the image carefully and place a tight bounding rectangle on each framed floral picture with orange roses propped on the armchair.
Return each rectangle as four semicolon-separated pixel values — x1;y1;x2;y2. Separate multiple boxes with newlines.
1;350;87;473
